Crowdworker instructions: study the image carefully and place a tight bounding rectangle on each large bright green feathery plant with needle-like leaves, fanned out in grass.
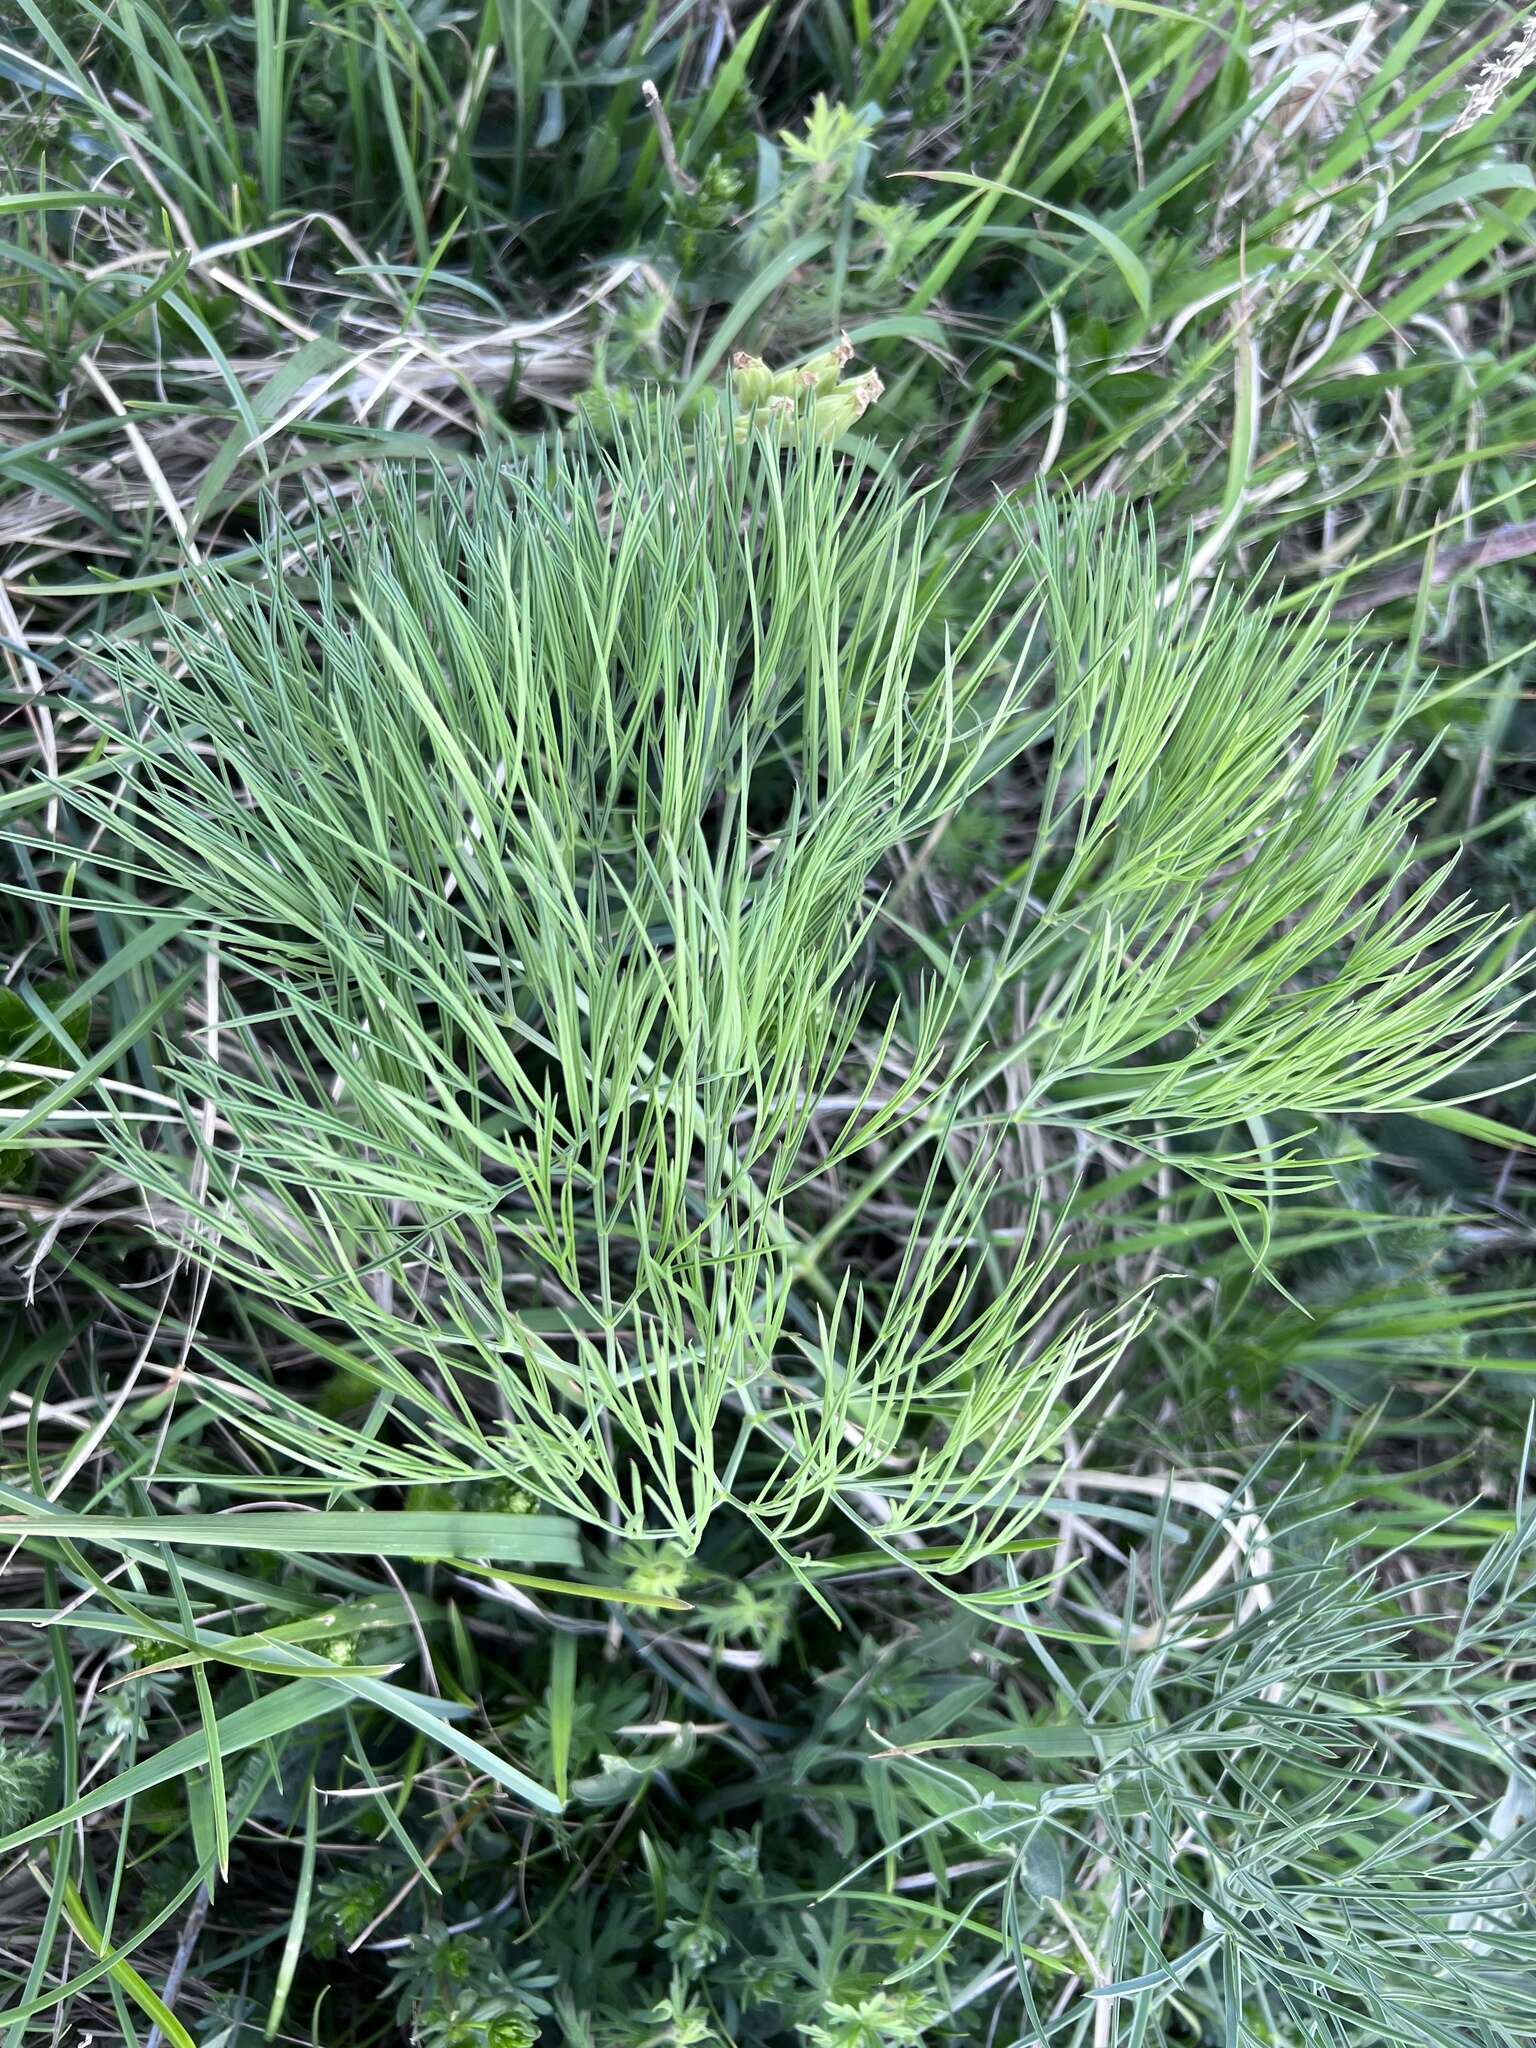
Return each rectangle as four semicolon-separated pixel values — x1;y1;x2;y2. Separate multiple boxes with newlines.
30;408;1523;1573
